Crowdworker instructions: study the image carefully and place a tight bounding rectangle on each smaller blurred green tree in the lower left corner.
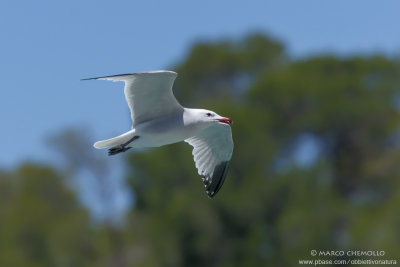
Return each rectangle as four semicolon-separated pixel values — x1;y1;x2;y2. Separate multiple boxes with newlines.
0;165;100;266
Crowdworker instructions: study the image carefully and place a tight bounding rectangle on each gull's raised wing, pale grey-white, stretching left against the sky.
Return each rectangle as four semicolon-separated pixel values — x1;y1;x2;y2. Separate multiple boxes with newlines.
84;70;182;126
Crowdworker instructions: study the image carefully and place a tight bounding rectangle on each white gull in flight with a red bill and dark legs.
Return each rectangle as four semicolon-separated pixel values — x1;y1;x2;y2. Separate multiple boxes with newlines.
83;70;233;198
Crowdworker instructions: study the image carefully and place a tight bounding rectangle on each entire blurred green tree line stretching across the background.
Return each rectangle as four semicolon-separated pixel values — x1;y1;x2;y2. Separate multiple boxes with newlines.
0;34;400;266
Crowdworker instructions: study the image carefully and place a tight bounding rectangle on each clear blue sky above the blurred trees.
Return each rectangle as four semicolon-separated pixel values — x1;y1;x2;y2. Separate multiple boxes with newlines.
0;0;400;167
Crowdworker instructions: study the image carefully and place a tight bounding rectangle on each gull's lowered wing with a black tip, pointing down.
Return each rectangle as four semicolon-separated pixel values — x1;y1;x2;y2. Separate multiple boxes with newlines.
185;123;233;198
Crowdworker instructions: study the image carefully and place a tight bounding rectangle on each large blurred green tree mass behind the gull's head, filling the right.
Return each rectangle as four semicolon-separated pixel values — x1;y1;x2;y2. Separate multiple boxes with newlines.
123;35;400;266
